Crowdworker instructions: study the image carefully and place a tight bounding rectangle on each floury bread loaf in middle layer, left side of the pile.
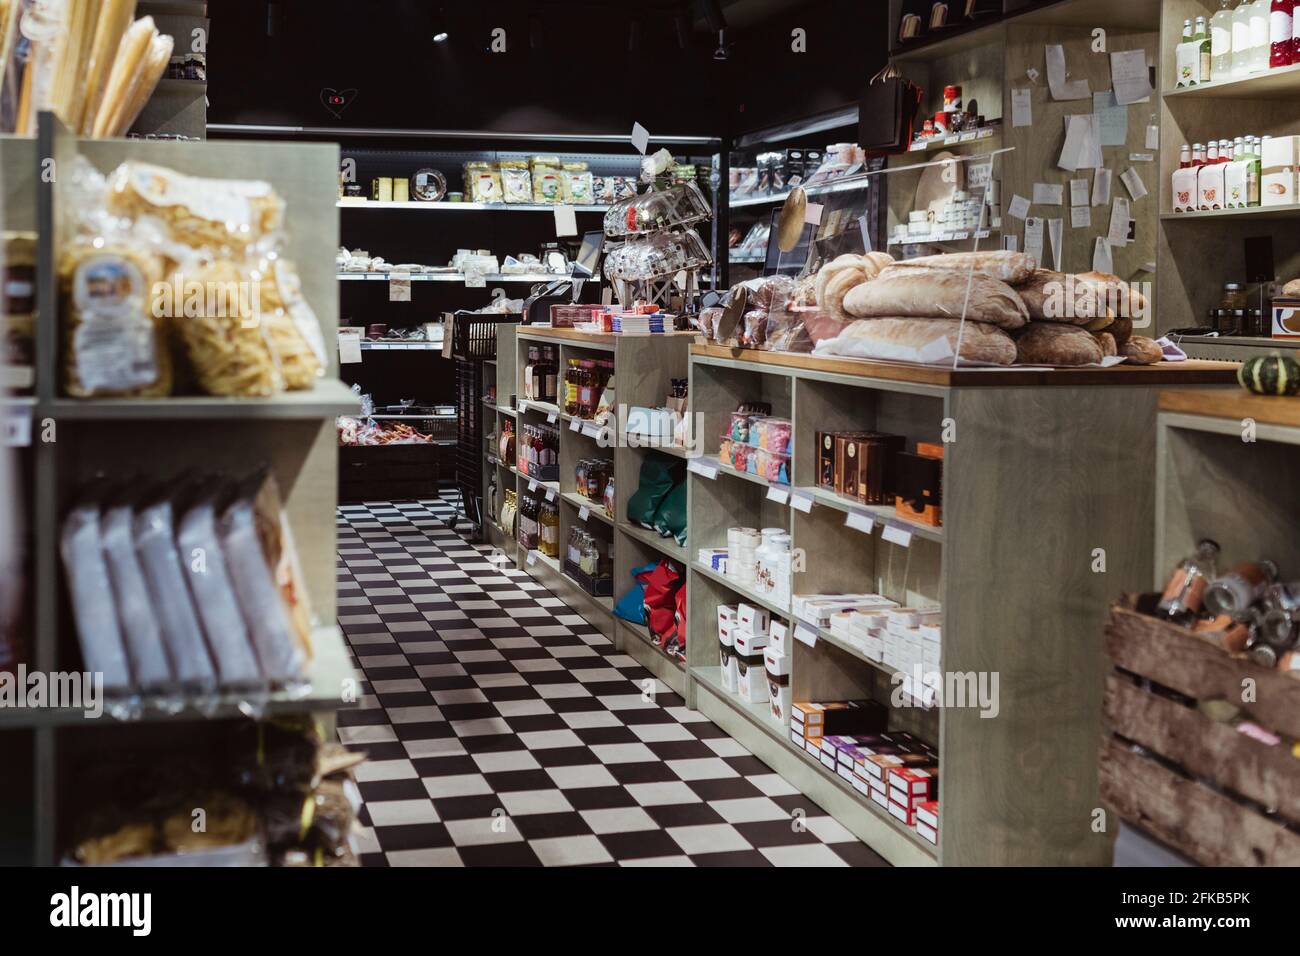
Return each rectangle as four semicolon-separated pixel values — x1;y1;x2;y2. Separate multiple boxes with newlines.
844;265;1030;329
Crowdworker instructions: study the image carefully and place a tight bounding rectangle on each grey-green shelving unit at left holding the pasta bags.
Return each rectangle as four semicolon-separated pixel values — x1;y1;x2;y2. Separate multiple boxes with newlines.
0;114;359;865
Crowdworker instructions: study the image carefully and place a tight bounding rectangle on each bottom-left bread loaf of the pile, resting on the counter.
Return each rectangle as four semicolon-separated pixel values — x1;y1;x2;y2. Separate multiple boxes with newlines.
814;317;1015;365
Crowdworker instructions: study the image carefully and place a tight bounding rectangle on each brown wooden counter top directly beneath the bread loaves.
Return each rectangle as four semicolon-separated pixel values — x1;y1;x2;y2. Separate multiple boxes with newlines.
690;343;1238;388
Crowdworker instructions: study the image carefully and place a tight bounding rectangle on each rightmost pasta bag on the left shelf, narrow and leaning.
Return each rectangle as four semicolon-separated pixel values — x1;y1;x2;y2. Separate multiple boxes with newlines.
252;252;326;392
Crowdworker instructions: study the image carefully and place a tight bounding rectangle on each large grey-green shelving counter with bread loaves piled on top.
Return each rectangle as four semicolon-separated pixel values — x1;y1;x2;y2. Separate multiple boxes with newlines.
686;345;1234;865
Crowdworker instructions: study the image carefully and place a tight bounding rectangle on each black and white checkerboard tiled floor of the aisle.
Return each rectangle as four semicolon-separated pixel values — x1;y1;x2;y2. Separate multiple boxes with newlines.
338;501;884;866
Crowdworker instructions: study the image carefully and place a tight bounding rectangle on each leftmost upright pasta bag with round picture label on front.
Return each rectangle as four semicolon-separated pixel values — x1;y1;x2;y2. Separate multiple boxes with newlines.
59;157;172;398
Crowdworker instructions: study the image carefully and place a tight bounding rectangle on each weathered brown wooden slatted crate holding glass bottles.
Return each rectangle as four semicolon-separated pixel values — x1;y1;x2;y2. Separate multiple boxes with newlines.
1100;598;1300;866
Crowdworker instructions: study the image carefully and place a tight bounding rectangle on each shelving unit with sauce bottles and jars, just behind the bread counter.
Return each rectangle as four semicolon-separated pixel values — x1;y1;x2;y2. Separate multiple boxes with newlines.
484;325;694;693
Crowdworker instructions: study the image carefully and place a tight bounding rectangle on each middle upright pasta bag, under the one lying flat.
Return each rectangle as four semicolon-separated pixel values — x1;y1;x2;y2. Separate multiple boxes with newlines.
166;256;285;398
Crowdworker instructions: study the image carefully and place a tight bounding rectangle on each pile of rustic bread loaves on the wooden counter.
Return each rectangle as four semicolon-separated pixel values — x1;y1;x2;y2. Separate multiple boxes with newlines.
816;251;1161;365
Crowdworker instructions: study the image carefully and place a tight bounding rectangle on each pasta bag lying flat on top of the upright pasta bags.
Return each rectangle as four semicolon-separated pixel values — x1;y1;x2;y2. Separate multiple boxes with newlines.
108;160;285;256
